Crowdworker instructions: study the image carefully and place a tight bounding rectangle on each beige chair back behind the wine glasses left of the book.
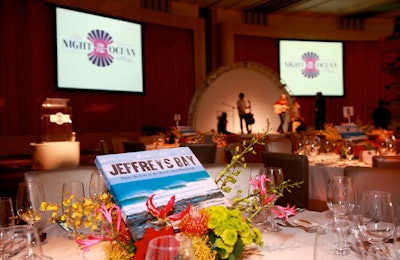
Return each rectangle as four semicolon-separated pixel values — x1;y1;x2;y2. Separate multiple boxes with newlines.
24;166;97;205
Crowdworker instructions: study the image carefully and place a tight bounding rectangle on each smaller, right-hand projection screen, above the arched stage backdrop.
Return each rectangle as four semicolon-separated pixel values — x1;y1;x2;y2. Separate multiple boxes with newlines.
279;40;344;97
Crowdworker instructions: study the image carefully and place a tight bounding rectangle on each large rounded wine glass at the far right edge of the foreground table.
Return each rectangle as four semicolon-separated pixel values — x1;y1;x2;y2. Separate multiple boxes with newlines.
358;191;396;259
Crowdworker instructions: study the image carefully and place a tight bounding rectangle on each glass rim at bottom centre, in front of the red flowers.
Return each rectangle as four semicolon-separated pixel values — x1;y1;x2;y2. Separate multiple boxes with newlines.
145;235;196;260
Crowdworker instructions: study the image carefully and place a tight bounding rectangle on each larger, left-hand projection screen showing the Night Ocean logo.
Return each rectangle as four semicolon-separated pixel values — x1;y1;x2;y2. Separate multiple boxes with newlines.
55;7;144;93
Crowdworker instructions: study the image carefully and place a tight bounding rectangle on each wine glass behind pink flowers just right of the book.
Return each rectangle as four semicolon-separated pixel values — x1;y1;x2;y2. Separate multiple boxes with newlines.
260;167;283;232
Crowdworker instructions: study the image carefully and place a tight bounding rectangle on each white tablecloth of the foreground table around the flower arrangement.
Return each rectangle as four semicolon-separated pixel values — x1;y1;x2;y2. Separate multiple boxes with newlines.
42;211;332;260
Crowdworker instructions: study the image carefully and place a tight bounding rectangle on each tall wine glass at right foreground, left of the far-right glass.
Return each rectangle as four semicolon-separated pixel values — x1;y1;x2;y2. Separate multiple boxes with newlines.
326;176;356;255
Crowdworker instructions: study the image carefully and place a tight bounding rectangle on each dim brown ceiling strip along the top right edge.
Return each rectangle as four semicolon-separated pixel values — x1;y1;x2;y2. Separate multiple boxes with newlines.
177;0;400;19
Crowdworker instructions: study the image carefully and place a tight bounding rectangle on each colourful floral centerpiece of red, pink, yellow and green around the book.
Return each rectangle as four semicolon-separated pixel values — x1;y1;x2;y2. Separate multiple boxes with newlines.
42;120;300;260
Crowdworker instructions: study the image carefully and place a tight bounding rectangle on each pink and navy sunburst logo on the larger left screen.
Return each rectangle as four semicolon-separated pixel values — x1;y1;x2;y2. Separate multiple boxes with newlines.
87;30;114;67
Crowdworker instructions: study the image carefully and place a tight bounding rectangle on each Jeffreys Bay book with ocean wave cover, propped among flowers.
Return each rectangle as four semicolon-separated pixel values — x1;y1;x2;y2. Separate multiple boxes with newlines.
95;147;229;240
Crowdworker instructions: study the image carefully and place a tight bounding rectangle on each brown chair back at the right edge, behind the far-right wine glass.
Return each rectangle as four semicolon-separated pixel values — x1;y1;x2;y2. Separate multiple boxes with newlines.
344;166;400;208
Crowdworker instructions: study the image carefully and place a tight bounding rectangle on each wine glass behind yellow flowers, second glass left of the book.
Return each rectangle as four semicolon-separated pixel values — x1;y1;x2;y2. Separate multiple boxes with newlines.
62;181;85;239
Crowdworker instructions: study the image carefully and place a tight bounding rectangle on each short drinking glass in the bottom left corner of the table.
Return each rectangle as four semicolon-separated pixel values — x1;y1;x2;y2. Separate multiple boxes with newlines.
3;225;43;260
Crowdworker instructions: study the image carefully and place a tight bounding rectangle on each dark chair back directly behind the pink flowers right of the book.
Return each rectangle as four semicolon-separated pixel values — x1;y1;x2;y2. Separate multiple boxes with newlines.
261;152;309;208
